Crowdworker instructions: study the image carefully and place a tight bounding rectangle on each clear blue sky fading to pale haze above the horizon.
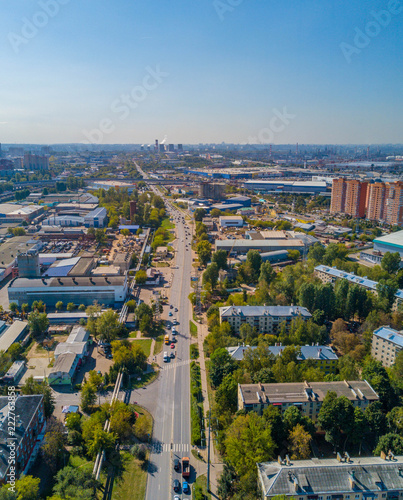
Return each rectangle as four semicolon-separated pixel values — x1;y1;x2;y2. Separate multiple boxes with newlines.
0;0;403;144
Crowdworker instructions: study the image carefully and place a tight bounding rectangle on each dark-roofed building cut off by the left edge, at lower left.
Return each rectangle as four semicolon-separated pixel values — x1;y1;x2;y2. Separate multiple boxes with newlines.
0;394;46;483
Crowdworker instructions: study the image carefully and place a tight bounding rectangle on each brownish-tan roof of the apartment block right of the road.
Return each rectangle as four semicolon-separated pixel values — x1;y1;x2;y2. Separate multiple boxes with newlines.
239;380;379;405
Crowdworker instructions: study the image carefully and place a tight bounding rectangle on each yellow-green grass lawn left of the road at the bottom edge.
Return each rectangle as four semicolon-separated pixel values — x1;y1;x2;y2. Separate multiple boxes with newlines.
112;452;147;500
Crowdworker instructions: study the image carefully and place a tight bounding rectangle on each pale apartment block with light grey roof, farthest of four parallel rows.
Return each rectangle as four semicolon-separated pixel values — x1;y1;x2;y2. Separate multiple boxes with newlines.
220;306;312;334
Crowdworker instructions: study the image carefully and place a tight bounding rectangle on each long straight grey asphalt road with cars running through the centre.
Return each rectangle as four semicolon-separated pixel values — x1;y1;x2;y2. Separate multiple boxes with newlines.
146;197;192;500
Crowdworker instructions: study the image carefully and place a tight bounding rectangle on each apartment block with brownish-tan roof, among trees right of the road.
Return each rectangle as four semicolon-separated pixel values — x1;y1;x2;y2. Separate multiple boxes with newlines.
238;380;379;420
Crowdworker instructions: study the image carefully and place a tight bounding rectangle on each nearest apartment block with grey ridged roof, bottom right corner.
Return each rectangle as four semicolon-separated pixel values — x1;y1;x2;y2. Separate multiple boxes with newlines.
257;455;403;500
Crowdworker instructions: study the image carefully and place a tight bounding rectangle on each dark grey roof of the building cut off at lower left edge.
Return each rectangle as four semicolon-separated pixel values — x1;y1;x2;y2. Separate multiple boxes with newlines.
0;394;43;479
